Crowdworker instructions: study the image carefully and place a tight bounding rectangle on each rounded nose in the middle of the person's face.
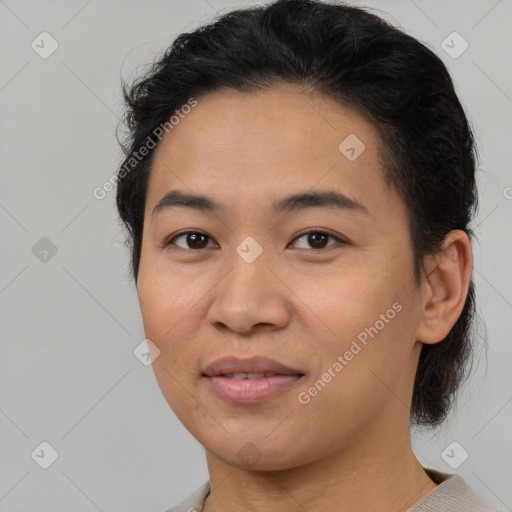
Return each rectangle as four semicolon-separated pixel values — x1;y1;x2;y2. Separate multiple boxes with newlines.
207;241;292;335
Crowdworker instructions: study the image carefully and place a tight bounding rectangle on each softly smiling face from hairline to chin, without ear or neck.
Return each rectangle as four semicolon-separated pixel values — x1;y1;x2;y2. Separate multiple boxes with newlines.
138;86;421;469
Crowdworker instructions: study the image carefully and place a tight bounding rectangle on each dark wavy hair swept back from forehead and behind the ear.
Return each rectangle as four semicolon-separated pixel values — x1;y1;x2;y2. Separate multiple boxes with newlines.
117;0;478;427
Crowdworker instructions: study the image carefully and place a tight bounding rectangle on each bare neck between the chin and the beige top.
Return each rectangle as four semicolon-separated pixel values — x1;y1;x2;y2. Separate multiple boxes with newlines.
204;418;436;512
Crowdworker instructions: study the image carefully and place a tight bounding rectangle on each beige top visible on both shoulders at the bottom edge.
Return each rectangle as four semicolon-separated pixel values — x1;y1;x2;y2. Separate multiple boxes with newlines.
162;467;498;512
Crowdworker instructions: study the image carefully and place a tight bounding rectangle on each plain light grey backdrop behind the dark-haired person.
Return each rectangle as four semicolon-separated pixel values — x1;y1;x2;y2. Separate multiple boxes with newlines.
0;0;512;512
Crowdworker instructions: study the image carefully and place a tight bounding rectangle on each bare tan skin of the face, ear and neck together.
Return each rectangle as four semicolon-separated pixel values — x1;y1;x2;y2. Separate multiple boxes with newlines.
138;85;473;512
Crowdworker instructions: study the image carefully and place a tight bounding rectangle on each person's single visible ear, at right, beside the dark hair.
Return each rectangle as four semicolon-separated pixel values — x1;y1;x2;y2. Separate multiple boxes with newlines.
416;229;473;344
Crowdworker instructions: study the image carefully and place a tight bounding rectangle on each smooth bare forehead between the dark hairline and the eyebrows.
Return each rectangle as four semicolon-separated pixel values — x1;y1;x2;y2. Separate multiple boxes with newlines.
147;85;396;220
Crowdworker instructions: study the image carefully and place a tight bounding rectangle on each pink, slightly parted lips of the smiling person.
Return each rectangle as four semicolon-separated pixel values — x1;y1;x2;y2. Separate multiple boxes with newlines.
203;356;304;405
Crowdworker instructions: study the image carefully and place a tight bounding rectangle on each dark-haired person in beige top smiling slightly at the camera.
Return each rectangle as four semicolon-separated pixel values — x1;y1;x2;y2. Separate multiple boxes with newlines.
117;0;492;512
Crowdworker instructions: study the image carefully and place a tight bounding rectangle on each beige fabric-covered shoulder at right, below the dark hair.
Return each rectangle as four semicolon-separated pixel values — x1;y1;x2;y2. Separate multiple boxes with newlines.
407;468;498;512
